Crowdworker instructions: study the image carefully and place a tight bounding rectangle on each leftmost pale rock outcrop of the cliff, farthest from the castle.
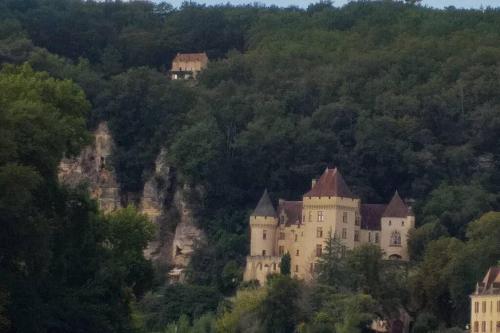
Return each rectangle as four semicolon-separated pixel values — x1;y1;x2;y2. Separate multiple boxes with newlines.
59;122;120;212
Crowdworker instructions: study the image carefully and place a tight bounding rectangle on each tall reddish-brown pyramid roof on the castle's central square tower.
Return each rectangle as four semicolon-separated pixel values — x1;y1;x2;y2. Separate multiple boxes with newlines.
304;168;356;198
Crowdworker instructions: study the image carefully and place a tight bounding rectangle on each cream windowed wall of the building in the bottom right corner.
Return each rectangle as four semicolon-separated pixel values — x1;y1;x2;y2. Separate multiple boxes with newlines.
470;295;500;333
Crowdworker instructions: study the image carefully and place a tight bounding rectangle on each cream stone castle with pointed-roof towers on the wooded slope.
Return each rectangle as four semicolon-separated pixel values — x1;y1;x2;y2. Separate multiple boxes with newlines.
244;168;415;285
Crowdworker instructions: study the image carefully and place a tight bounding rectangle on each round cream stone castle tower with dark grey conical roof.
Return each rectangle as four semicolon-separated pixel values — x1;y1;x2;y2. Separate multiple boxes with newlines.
250;190;278;256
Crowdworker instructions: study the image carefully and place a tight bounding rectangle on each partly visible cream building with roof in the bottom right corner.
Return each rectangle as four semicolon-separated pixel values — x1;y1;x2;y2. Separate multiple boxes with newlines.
470;267;500;333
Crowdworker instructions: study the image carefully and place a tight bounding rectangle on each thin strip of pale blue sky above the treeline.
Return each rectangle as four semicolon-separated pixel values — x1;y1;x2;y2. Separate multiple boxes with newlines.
166;0;500;8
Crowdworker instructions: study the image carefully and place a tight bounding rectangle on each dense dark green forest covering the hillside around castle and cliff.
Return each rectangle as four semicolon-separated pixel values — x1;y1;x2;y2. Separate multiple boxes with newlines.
0;0;500;333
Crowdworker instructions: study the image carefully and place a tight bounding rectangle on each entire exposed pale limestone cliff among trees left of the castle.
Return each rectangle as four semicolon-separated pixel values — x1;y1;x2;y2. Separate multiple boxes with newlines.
59;122;205;281
